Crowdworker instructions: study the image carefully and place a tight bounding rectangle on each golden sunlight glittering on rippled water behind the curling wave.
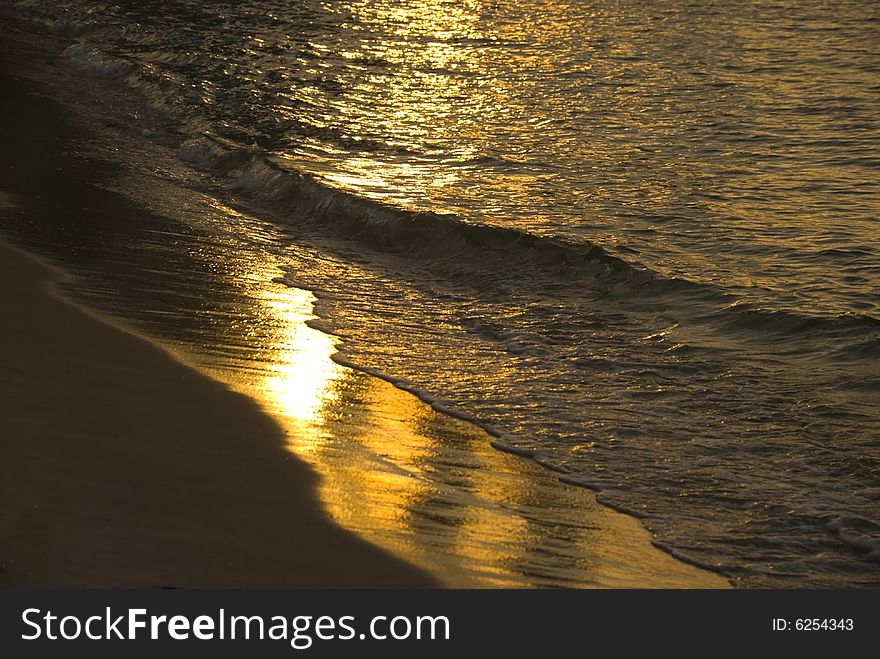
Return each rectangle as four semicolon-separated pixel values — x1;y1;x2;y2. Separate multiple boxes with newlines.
275;0;584;226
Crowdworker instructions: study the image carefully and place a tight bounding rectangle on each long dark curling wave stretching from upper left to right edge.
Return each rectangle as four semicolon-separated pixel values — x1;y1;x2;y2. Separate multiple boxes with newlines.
64;41;880;350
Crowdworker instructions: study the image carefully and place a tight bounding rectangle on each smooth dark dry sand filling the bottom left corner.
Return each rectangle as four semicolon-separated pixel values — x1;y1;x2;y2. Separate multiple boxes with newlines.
0;244;432;587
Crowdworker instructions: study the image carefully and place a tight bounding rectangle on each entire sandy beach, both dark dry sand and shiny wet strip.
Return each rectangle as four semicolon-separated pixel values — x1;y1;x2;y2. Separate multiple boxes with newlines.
0;25;727;587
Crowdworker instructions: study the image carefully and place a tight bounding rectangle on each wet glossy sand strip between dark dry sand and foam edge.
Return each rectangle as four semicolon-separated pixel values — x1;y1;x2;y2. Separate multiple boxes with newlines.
0;21;729;588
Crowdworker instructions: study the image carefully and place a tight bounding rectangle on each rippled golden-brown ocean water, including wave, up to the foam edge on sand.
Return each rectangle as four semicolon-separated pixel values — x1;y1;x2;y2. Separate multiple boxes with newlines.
13;0;880;586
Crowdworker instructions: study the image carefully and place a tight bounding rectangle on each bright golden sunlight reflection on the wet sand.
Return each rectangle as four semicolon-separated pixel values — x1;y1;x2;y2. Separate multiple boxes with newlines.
226;269;721;587
